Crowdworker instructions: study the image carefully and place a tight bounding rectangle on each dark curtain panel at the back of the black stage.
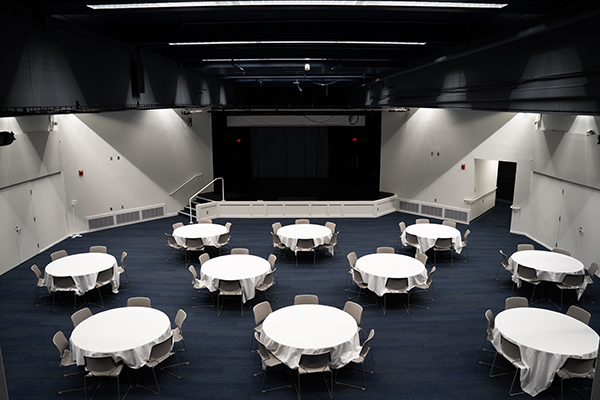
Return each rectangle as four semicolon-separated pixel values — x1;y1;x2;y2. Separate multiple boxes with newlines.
251;127;329;178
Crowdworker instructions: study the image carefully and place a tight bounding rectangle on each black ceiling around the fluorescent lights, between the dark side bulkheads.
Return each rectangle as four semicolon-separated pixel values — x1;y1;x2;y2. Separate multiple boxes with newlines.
0;0;598;108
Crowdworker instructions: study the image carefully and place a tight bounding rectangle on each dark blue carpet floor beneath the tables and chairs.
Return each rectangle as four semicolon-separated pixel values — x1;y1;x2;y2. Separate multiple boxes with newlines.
0;204;600;400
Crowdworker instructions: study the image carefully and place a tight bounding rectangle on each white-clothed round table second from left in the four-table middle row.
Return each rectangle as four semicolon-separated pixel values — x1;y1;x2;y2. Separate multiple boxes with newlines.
200;254;271;303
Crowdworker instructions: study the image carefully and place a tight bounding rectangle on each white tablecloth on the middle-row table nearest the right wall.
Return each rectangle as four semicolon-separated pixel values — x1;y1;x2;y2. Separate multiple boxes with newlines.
508;250;587;298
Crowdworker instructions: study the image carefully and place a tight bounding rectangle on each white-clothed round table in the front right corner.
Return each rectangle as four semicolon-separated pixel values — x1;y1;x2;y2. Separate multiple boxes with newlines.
492;307;599;396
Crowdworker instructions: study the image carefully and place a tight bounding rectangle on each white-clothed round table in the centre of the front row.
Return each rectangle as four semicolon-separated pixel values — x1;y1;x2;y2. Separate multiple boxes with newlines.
260;304;360;369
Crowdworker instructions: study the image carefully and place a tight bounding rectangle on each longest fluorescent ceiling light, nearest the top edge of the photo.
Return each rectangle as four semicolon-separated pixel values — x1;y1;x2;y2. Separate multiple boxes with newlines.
88;0;508;10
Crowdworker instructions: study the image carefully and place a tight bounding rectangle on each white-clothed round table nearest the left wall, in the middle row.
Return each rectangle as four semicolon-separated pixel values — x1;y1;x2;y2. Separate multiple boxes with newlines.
44;253;119;296
